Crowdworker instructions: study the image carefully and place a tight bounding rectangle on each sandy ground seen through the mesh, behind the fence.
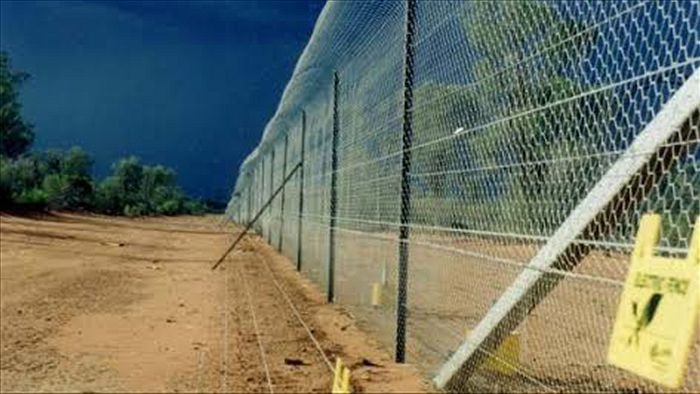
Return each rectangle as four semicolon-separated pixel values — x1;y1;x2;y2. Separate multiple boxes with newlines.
270;222;700;393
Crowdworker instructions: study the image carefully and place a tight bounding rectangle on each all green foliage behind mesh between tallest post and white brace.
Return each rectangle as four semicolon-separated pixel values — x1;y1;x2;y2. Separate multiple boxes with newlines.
404;1;614;234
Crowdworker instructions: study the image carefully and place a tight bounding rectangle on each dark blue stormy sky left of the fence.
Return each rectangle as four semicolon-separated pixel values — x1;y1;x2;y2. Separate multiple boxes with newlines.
0;0;323;201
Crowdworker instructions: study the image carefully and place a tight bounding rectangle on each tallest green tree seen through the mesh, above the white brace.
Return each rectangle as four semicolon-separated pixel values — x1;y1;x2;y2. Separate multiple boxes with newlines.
462;1;609;234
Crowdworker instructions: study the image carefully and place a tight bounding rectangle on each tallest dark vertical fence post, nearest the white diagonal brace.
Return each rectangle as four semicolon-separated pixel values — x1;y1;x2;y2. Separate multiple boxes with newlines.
396;0;416;363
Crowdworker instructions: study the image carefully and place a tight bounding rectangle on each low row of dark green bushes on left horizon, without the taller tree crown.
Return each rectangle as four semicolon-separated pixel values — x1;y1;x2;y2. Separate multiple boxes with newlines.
0;148;208;217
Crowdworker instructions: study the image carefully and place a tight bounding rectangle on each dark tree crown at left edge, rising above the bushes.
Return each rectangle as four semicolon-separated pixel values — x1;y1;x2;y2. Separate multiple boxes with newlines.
0;52;34;158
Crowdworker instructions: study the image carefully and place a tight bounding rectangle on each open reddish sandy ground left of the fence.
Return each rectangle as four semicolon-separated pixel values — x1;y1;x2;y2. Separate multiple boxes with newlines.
0;214;427;392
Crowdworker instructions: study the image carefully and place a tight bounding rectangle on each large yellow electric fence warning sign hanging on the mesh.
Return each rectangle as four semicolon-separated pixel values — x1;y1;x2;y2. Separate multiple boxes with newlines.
608;215;700;388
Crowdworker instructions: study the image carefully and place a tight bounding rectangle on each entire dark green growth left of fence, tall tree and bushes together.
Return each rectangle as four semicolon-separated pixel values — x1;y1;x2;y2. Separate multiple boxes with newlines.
0;52;208;217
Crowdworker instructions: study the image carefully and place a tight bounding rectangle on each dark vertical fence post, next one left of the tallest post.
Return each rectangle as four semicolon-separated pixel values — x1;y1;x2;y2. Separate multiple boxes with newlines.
328;71;339;302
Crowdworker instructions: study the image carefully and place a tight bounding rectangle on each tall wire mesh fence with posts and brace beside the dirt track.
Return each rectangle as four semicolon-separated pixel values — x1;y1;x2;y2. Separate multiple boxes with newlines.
228;1;700;392
